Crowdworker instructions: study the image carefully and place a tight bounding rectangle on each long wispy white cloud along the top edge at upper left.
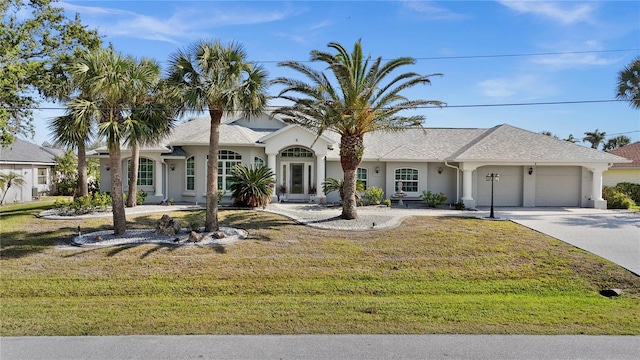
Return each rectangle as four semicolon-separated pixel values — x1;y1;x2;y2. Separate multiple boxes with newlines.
59;2;292;43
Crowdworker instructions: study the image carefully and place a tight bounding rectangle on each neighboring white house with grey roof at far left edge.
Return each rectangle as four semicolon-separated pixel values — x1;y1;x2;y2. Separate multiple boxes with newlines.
0;138;62;203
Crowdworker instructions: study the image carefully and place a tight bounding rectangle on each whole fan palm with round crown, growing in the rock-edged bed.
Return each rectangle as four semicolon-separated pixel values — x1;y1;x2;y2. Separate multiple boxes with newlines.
169;40;267;232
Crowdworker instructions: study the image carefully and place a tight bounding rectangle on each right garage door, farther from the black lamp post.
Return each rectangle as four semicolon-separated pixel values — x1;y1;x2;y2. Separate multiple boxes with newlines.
535;166;582;206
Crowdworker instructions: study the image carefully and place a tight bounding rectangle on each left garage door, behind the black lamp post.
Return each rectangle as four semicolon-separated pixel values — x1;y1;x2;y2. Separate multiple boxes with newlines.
477;166;523;206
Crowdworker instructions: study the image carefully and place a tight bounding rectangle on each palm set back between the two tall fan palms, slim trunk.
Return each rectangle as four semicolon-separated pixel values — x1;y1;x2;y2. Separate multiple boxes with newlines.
125;66;177;207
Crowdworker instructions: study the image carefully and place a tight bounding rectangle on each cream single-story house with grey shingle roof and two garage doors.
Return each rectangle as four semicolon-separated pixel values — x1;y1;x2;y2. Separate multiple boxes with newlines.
89;114;628;208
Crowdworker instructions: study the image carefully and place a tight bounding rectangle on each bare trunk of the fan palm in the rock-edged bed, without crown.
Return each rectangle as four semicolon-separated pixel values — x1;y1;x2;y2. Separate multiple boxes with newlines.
204;107;223;232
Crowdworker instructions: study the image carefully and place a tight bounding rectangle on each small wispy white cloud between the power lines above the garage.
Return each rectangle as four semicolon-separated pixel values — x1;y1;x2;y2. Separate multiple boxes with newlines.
478;75;556;100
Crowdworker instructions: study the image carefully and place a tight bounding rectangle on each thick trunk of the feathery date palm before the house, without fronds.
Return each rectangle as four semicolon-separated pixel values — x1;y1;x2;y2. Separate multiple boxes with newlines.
340;134;364;220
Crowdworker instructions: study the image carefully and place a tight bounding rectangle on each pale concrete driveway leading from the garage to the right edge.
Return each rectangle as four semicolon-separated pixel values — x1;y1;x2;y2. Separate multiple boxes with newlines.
498;208;640;275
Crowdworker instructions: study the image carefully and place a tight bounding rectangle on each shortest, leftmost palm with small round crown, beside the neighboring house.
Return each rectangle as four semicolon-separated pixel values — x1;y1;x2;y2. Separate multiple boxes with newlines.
49;109;95;196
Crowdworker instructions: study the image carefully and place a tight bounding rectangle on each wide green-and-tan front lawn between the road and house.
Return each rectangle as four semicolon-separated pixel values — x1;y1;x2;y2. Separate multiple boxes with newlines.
0;202;640;336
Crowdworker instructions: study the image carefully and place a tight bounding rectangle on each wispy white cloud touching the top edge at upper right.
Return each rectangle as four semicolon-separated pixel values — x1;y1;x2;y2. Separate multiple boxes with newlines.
498;0;595;25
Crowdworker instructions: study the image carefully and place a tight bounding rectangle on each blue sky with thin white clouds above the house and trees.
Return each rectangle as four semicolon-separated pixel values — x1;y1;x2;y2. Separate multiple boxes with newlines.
28;0;640;146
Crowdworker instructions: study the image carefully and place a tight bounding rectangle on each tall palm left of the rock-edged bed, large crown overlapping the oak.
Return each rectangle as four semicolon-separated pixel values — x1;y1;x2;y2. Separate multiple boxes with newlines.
67;49;157;235
